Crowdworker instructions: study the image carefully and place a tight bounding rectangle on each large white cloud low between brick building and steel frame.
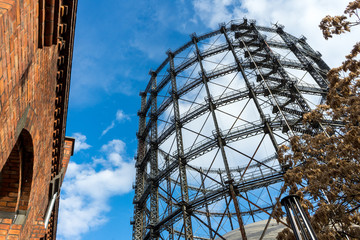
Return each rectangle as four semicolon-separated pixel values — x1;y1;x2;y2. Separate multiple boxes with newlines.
58;139;135;240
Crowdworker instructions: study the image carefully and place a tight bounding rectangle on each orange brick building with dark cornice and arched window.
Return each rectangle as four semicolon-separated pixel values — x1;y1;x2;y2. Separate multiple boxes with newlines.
0;0;77;240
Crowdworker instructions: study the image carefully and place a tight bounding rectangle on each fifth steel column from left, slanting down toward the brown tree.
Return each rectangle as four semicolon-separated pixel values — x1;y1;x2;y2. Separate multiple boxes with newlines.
220;26;279;151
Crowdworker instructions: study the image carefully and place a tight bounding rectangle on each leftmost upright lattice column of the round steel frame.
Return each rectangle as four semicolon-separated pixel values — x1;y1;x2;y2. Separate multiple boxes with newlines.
133;92;146;240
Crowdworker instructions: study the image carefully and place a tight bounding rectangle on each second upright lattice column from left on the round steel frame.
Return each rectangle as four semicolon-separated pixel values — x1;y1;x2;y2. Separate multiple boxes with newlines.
149;71;159;240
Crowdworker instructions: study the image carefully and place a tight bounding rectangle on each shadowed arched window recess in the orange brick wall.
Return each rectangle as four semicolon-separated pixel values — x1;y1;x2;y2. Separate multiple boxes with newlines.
0;129;34;223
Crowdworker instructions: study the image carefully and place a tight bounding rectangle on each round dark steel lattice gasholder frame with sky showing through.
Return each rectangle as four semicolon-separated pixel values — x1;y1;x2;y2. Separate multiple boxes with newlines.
132;19;335;240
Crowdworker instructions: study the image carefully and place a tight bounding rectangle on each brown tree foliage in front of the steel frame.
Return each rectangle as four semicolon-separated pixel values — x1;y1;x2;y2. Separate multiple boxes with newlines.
275;0;360;240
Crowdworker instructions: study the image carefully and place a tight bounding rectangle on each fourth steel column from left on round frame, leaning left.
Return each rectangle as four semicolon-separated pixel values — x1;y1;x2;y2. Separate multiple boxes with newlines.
192;36;247;240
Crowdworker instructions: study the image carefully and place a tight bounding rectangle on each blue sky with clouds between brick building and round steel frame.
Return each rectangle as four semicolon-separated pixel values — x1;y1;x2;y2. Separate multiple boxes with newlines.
58;0;358;240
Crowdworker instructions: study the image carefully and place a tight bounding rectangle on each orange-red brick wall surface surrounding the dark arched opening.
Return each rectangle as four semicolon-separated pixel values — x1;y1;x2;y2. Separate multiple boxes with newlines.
0;0;76;240
